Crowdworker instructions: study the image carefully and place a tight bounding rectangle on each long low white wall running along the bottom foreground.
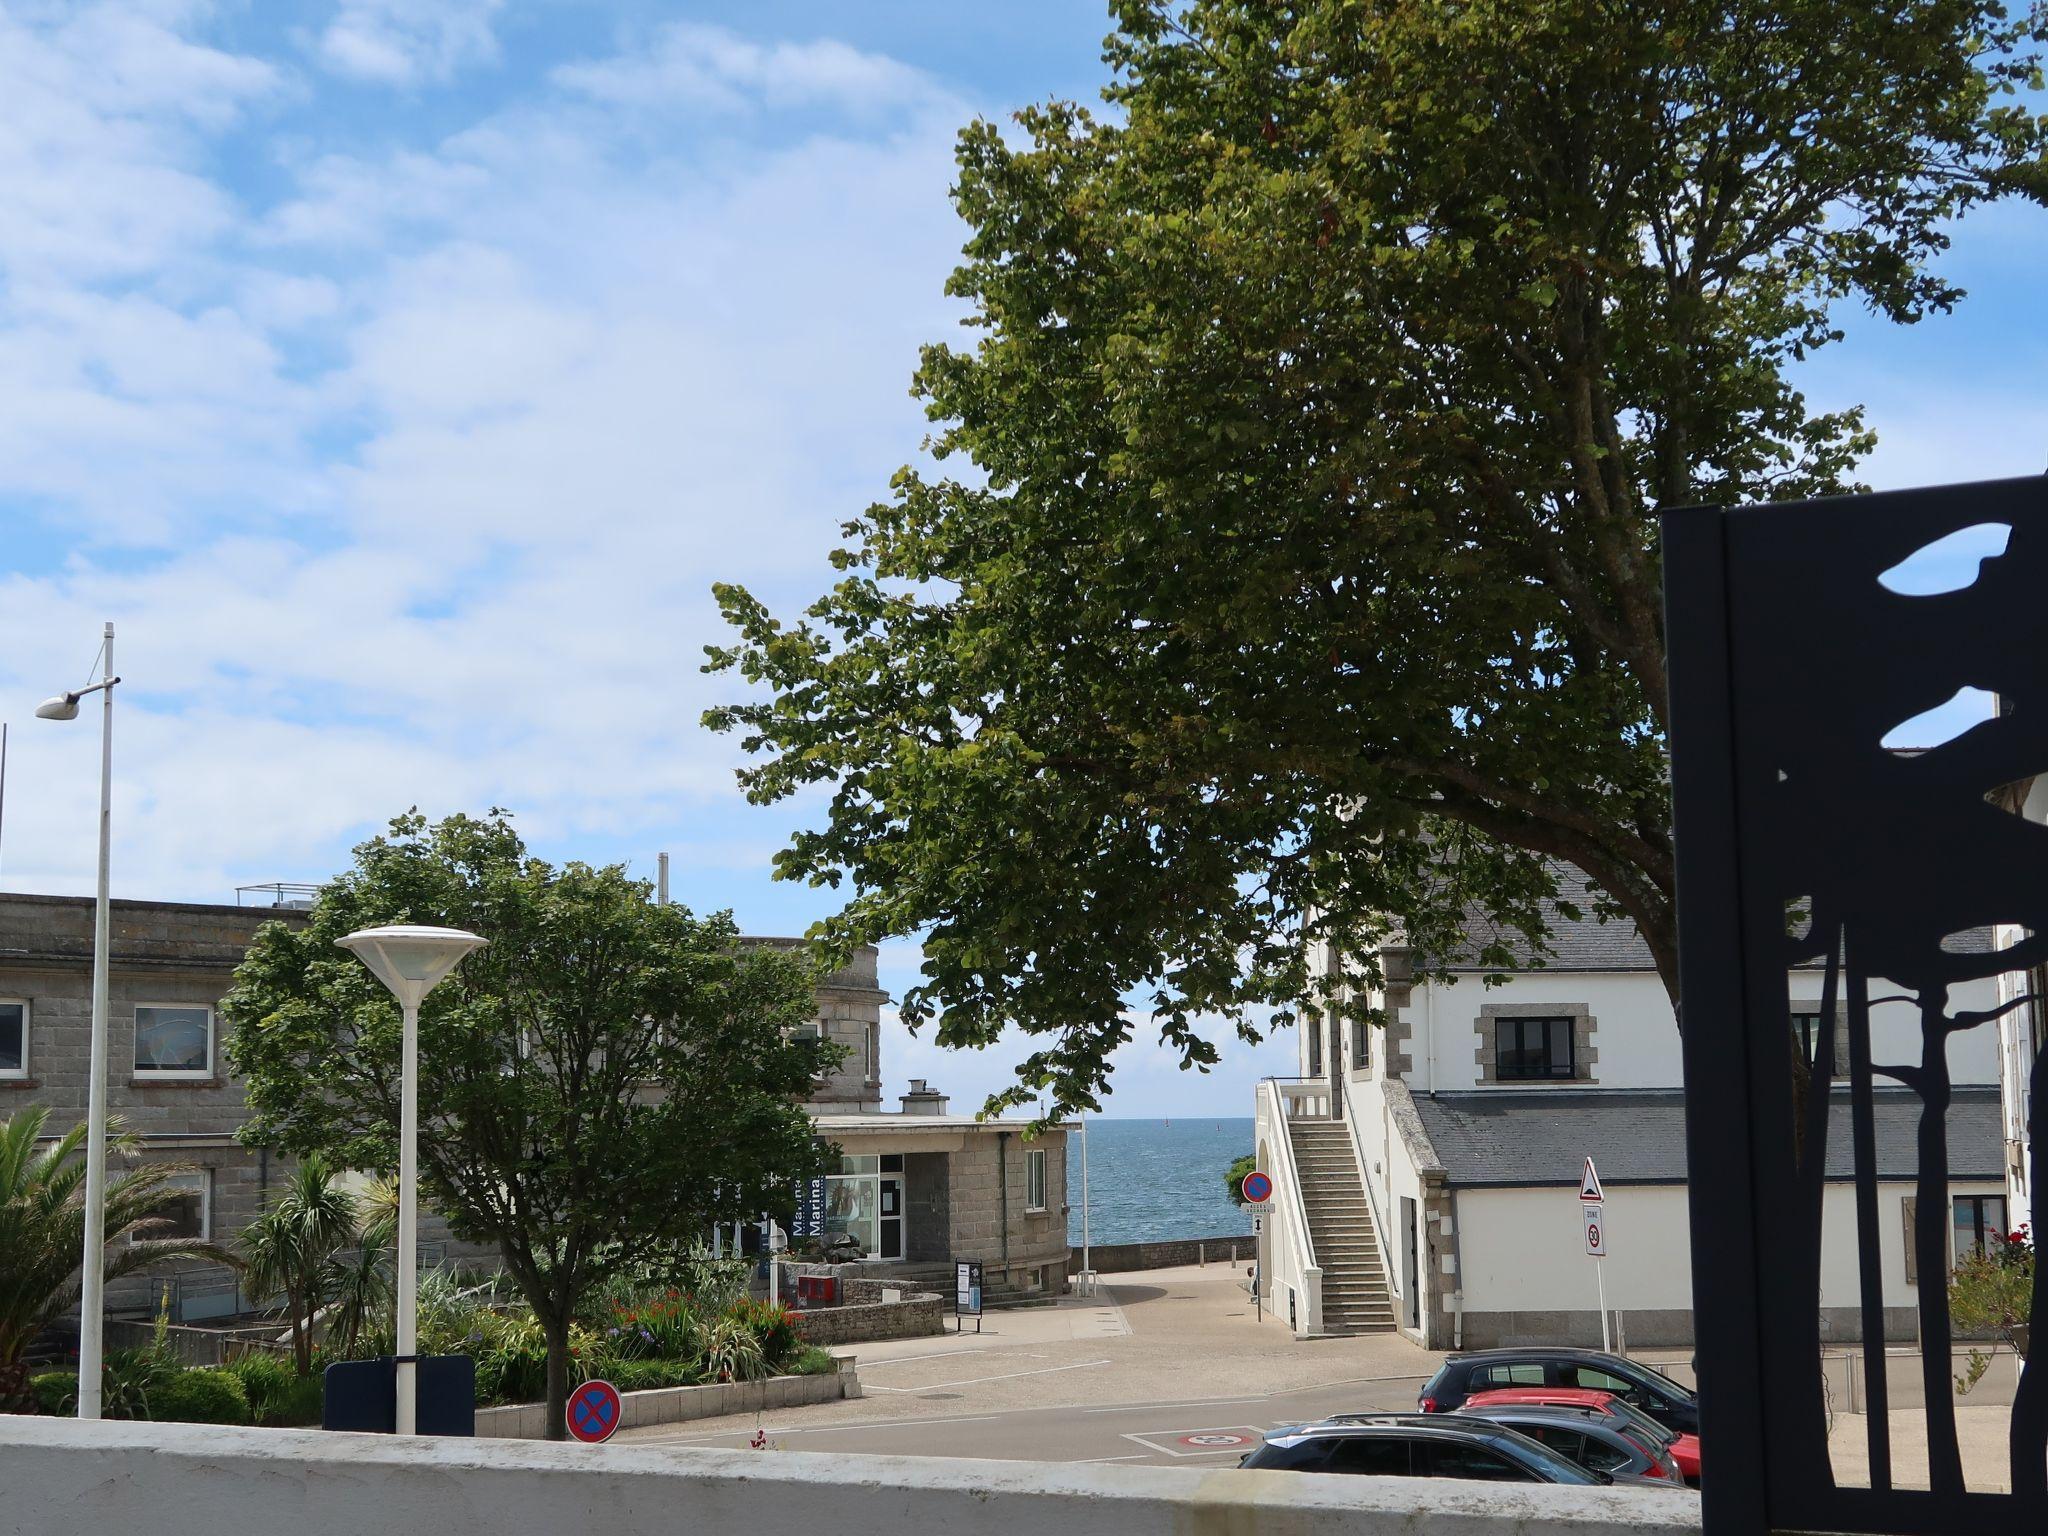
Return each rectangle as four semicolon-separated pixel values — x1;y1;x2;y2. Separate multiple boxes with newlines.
0;1417;1700;1536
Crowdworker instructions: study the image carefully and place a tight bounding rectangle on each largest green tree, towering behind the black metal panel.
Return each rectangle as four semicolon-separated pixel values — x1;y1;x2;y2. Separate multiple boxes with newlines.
707;0;2048;1108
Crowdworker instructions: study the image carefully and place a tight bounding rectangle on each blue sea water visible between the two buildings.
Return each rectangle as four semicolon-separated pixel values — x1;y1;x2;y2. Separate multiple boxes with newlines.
1067;1114;1251;1245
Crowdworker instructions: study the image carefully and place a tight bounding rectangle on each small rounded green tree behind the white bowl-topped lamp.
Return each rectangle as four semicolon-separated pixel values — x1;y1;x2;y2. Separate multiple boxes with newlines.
221;813;829;1438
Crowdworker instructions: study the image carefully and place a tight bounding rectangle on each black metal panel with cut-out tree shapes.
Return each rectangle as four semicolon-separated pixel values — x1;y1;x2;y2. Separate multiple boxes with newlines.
1663;479;2048;1536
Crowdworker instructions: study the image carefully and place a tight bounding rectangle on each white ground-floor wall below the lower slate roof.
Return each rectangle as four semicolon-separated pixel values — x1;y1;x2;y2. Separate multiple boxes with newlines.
1458;1182;1999;1313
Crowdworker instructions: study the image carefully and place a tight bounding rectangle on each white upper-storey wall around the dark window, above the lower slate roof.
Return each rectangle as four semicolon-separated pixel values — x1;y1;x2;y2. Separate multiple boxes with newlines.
1403;971;1999;1094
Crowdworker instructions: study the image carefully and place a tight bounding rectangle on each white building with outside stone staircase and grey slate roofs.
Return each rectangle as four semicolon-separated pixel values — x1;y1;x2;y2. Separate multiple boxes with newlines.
1257;874;2009;1348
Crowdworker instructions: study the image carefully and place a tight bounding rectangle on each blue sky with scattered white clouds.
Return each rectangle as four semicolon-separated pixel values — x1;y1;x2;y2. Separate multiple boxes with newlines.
0;0;2048;1116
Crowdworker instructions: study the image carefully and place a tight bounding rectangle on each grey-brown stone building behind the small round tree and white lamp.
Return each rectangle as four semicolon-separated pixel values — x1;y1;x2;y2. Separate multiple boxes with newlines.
0;893;1067;1321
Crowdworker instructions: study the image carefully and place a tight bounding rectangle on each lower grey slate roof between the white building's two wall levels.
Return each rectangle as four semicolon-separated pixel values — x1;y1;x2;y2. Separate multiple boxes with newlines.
1415;1087;2005;1188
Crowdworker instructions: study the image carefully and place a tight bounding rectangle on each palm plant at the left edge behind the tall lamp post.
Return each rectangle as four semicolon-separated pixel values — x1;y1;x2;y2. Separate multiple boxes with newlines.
0;1106;236;1409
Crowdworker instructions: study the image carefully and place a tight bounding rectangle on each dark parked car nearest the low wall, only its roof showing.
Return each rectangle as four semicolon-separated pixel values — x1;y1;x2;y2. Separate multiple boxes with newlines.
1237;1413;1671;1487
